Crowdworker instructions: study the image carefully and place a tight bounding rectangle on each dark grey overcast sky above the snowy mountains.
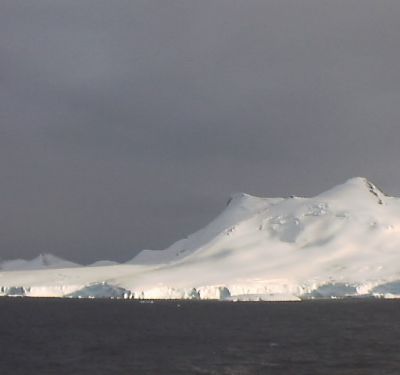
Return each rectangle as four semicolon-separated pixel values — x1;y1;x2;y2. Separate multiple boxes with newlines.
0;0;400;263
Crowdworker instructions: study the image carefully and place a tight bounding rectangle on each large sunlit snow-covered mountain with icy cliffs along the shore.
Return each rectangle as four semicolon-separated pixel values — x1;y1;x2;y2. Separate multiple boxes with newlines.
0;178;400;300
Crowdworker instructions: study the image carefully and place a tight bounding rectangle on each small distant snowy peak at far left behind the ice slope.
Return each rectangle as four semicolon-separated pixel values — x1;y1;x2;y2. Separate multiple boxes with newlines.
0;254;81;271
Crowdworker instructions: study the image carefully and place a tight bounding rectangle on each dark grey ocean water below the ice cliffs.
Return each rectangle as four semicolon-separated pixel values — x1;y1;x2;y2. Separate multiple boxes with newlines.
0;298;400;375
